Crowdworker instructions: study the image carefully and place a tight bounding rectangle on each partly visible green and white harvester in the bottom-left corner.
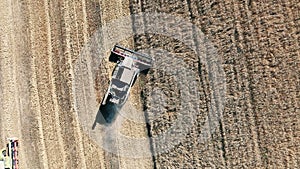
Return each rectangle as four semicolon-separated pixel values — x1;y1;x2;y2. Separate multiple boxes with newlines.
0;138;19;169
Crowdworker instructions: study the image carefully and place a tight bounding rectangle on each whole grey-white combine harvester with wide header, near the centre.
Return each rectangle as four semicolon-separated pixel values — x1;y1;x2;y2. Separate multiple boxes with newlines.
102;45;153;106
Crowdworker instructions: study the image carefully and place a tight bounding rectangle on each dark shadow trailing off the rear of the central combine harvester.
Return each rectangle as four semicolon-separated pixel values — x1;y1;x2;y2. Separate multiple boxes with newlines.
92;102;120;130
